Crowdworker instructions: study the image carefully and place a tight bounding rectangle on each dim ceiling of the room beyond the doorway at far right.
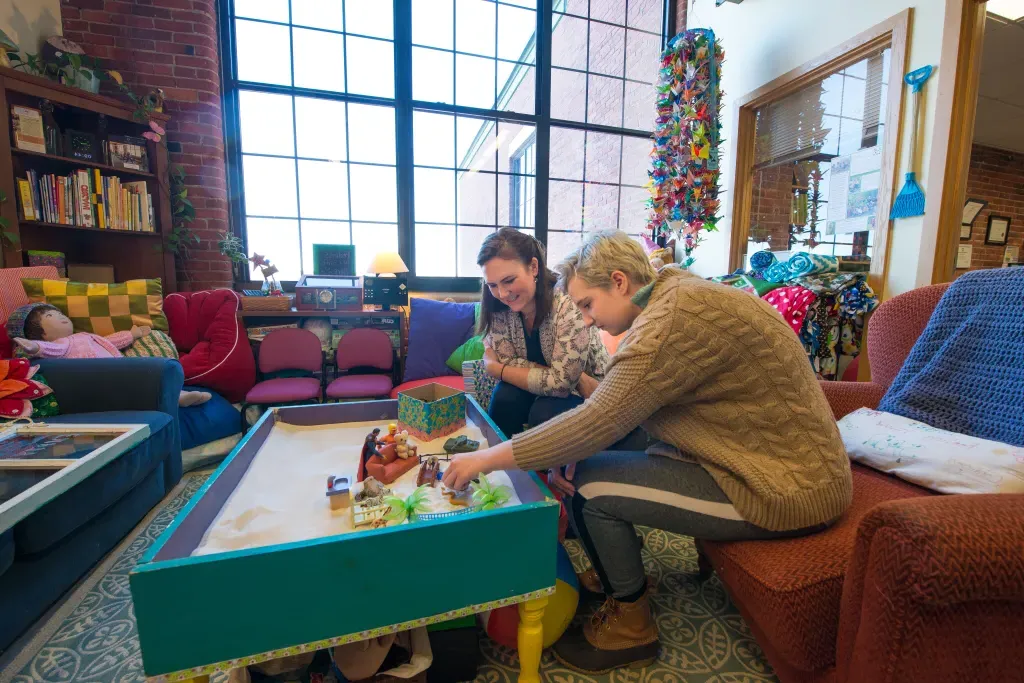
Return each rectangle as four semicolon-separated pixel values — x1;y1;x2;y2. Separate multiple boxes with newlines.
974;14;1024;153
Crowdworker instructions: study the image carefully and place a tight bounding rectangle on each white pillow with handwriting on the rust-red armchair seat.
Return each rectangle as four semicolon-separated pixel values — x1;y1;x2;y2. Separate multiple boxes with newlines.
839;408;1024;494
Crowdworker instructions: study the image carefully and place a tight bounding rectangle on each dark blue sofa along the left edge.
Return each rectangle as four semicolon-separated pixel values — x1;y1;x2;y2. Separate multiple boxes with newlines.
0;358;184;652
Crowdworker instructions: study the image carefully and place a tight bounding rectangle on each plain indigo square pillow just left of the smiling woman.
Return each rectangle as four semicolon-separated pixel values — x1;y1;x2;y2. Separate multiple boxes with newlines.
402;299;476;382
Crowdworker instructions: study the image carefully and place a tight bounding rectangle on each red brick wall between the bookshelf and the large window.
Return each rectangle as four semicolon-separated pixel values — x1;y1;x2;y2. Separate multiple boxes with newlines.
60;0;231;290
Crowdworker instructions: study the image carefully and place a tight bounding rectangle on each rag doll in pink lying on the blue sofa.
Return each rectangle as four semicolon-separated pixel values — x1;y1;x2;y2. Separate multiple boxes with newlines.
8;304;210;408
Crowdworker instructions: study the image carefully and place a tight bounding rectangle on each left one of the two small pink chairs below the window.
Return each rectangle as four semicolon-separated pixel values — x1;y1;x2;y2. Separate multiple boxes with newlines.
242;328;324;419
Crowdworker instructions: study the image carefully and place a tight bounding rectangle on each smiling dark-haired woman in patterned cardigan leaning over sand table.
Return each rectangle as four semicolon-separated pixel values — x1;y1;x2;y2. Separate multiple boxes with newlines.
476;227;608;446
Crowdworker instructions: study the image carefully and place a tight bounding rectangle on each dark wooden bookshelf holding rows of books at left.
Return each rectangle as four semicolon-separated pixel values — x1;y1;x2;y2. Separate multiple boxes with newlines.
0;68;177;293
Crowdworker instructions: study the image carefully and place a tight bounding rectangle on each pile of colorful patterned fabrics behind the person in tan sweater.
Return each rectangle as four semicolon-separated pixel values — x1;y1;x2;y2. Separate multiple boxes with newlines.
713;252;879;380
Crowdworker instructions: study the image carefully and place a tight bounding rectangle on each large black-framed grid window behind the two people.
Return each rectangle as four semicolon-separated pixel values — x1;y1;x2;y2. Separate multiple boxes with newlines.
221;0;669;282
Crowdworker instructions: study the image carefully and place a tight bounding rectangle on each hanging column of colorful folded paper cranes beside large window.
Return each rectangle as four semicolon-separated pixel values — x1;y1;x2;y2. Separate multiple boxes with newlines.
647;29;725;266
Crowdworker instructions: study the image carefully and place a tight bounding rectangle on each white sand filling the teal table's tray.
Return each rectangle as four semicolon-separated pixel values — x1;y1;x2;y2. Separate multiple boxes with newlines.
193;422;519;555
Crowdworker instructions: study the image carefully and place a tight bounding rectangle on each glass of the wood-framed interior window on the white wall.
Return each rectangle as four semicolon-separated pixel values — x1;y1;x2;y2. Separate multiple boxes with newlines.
748;48;890;261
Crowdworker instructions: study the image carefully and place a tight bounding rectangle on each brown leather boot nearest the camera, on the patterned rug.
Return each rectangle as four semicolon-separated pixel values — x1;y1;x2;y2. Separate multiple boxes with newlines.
554;595;657;674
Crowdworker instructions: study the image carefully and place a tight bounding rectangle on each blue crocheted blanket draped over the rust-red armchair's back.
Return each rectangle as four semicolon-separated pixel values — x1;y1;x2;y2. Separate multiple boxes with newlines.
879;267;1024;446
